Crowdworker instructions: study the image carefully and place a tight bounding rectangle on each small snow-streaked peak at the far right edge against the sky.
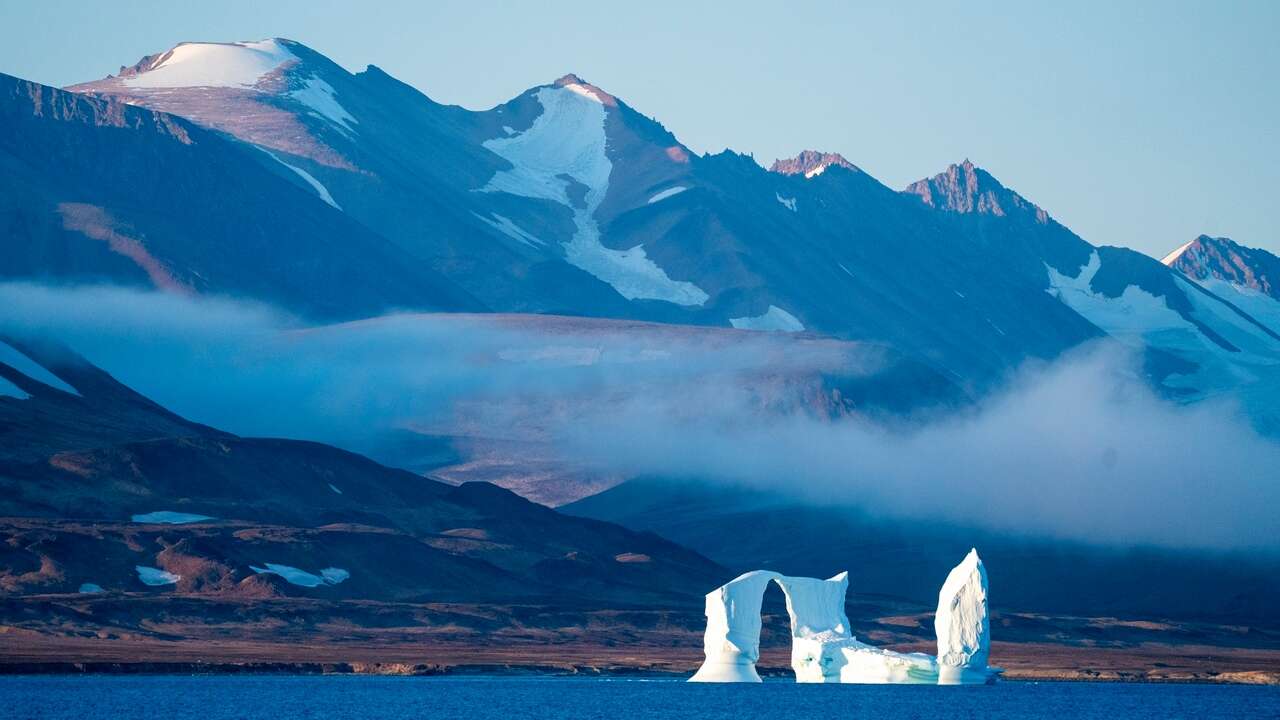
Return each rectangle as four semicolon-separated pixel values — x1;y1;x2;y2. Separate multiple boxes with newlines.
1161;234;1280;332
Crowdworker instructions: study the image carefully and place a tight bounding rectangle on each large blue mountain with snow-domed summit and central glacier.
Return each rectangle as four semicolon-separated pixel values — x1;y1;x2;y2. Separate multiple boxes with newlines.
72;40;1100;387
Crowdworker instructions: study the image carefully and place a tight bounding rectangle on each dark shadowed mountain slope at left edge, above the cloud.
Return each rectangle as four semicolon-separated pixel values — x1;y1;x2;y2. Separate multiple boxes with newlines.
0;76;481;318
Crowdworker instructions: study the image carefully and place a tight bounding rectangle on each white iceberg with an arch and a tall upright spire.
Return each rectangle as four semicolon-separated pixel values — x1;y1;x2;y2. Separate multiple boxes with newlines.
690;550;1000;684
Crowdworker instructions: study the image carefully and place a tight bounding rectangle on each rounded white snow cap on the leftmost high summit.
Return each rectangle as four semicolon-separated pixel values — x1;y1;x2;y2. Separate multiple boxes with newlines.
124;40;297;87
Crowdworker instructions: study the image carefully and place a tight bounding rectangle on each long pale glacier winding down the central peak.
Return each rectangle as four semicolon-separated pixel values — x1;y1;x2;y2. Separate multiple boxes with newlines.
480;83;708;305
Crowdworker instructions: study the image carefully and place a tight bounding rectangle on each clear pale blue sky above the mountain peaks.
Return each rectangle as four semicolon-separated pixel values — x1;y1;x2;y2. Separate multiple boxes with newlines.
0;0;1280;256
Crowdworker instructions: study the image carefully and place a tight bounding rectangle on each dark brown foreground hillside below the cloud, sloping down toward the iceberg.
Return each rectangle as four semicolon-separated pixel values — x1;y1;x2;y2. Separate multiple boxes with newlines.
0;338;724;602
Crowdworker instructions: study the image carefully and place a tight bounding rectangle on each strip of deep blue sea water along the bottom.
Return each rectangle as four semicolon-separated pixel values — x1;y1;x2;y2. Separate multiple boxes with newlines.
0;676;1280;720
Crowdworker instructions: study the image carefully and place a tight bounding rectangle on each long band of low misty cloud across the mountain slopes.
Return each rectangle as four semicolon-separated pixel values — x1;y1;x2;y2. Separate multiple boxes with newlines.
0;283;1280;547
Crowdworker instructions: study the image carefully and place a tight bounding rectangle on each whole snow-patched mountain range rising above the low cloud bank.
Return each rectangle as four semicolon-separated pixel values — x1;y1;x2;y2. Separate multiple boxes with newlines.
5;38;1264;407
